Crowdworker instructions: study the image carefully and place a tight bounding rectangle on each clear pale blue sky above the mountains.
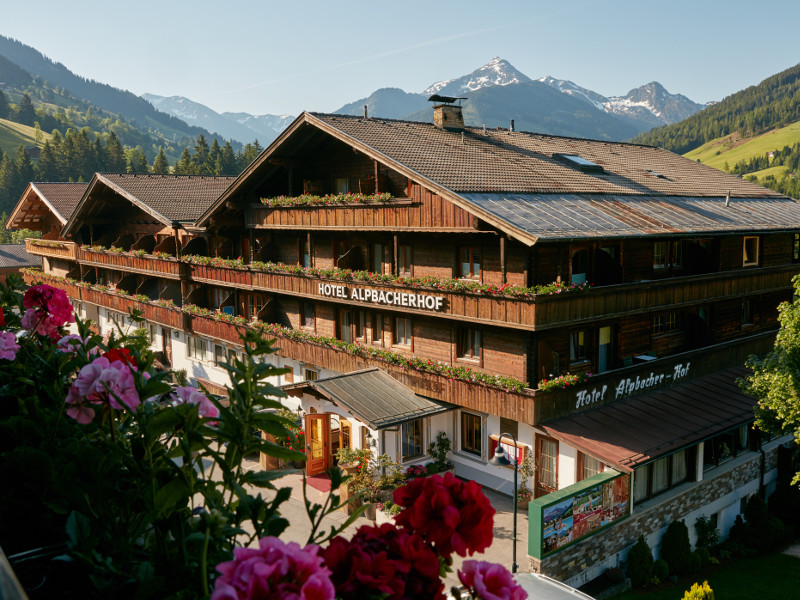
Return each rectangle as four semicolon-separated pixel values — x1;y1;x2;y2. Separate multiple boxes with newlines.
0;0;800;115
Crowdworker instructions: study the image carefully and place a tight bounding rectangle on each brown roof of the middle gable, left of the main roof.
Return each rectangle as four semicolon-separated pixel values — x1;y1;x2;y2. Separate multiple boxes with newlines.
63;173;236;235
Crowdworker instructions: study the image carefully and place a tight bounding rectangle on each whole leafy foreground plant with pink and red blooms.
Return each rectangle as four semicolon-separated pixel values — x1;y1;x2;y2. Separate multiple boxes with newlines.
0;278;528;600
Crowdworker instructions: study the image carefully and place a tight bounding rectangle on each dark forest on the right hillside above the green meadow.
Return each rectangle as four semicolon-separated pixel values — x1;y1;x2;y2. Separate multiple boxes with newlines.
632;64;800;154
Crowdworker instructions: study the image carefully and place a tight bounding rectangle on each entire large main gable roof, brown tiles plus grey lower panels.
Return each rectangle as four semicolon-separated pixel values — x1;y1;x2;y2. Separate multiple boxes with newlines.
198;113;800;244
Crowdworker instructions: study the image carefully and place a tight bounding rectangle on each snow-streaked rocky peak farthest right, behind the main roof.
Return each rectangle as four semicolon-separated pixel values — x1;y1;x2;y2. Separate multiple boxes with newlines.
537;75;705;127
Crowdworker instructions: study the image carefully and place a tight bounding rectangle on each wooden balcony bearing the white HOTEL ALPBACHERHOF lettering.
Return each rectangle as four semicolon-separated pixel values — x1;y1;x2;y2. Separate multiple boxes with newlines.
181;264;800;331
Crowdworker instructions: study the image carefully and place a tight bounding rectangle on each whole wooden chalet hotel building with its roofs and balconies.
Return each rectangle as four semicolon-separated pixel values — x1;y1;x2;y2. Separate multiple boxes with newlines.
12;105;800;584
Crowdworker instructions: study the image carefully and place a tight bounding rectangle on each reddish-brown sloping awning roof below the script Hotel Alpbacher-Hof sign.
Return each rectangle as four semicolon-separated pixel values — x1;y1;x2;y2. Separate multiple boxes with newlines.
542;367;756;472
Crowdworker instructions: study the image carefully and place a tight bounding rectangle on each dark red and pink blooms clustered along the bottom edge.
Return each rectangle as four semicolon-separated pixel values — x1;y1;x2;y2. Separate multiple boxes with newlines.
212;473;527;600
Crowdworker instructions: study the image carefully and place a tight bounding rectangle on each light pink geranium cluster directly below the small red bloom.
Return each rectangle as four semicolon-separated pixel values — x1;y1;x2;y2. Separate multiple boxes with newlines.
65;356;141;425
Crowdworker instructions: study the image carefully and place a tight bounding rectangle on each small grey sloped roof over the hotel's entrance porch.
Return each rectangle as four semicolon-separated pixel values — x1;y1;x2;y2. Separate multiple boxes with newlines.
282;367;454;429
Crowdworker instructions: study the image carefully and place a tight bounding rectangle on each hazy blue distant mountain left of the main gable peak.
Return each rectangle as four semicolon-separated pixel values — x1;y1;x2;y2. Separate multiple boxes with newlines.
142;94;294;146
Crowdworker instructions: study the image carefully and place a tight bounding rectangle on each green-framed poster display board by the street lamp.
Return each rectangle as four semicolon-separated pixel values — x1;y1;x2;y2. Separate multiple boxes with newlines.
528;471;631;559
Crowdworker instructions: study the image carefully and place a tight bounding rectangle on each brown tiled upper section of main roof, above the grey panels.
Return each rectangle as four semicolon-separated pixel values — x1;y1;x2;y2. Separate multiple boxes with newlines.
311;113;780;197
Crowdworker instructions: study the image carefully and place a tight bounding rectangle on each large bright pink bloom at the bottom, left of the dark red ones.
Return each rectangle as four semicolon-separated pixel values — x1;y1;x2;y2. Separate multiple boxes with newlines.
211;537;336;600
